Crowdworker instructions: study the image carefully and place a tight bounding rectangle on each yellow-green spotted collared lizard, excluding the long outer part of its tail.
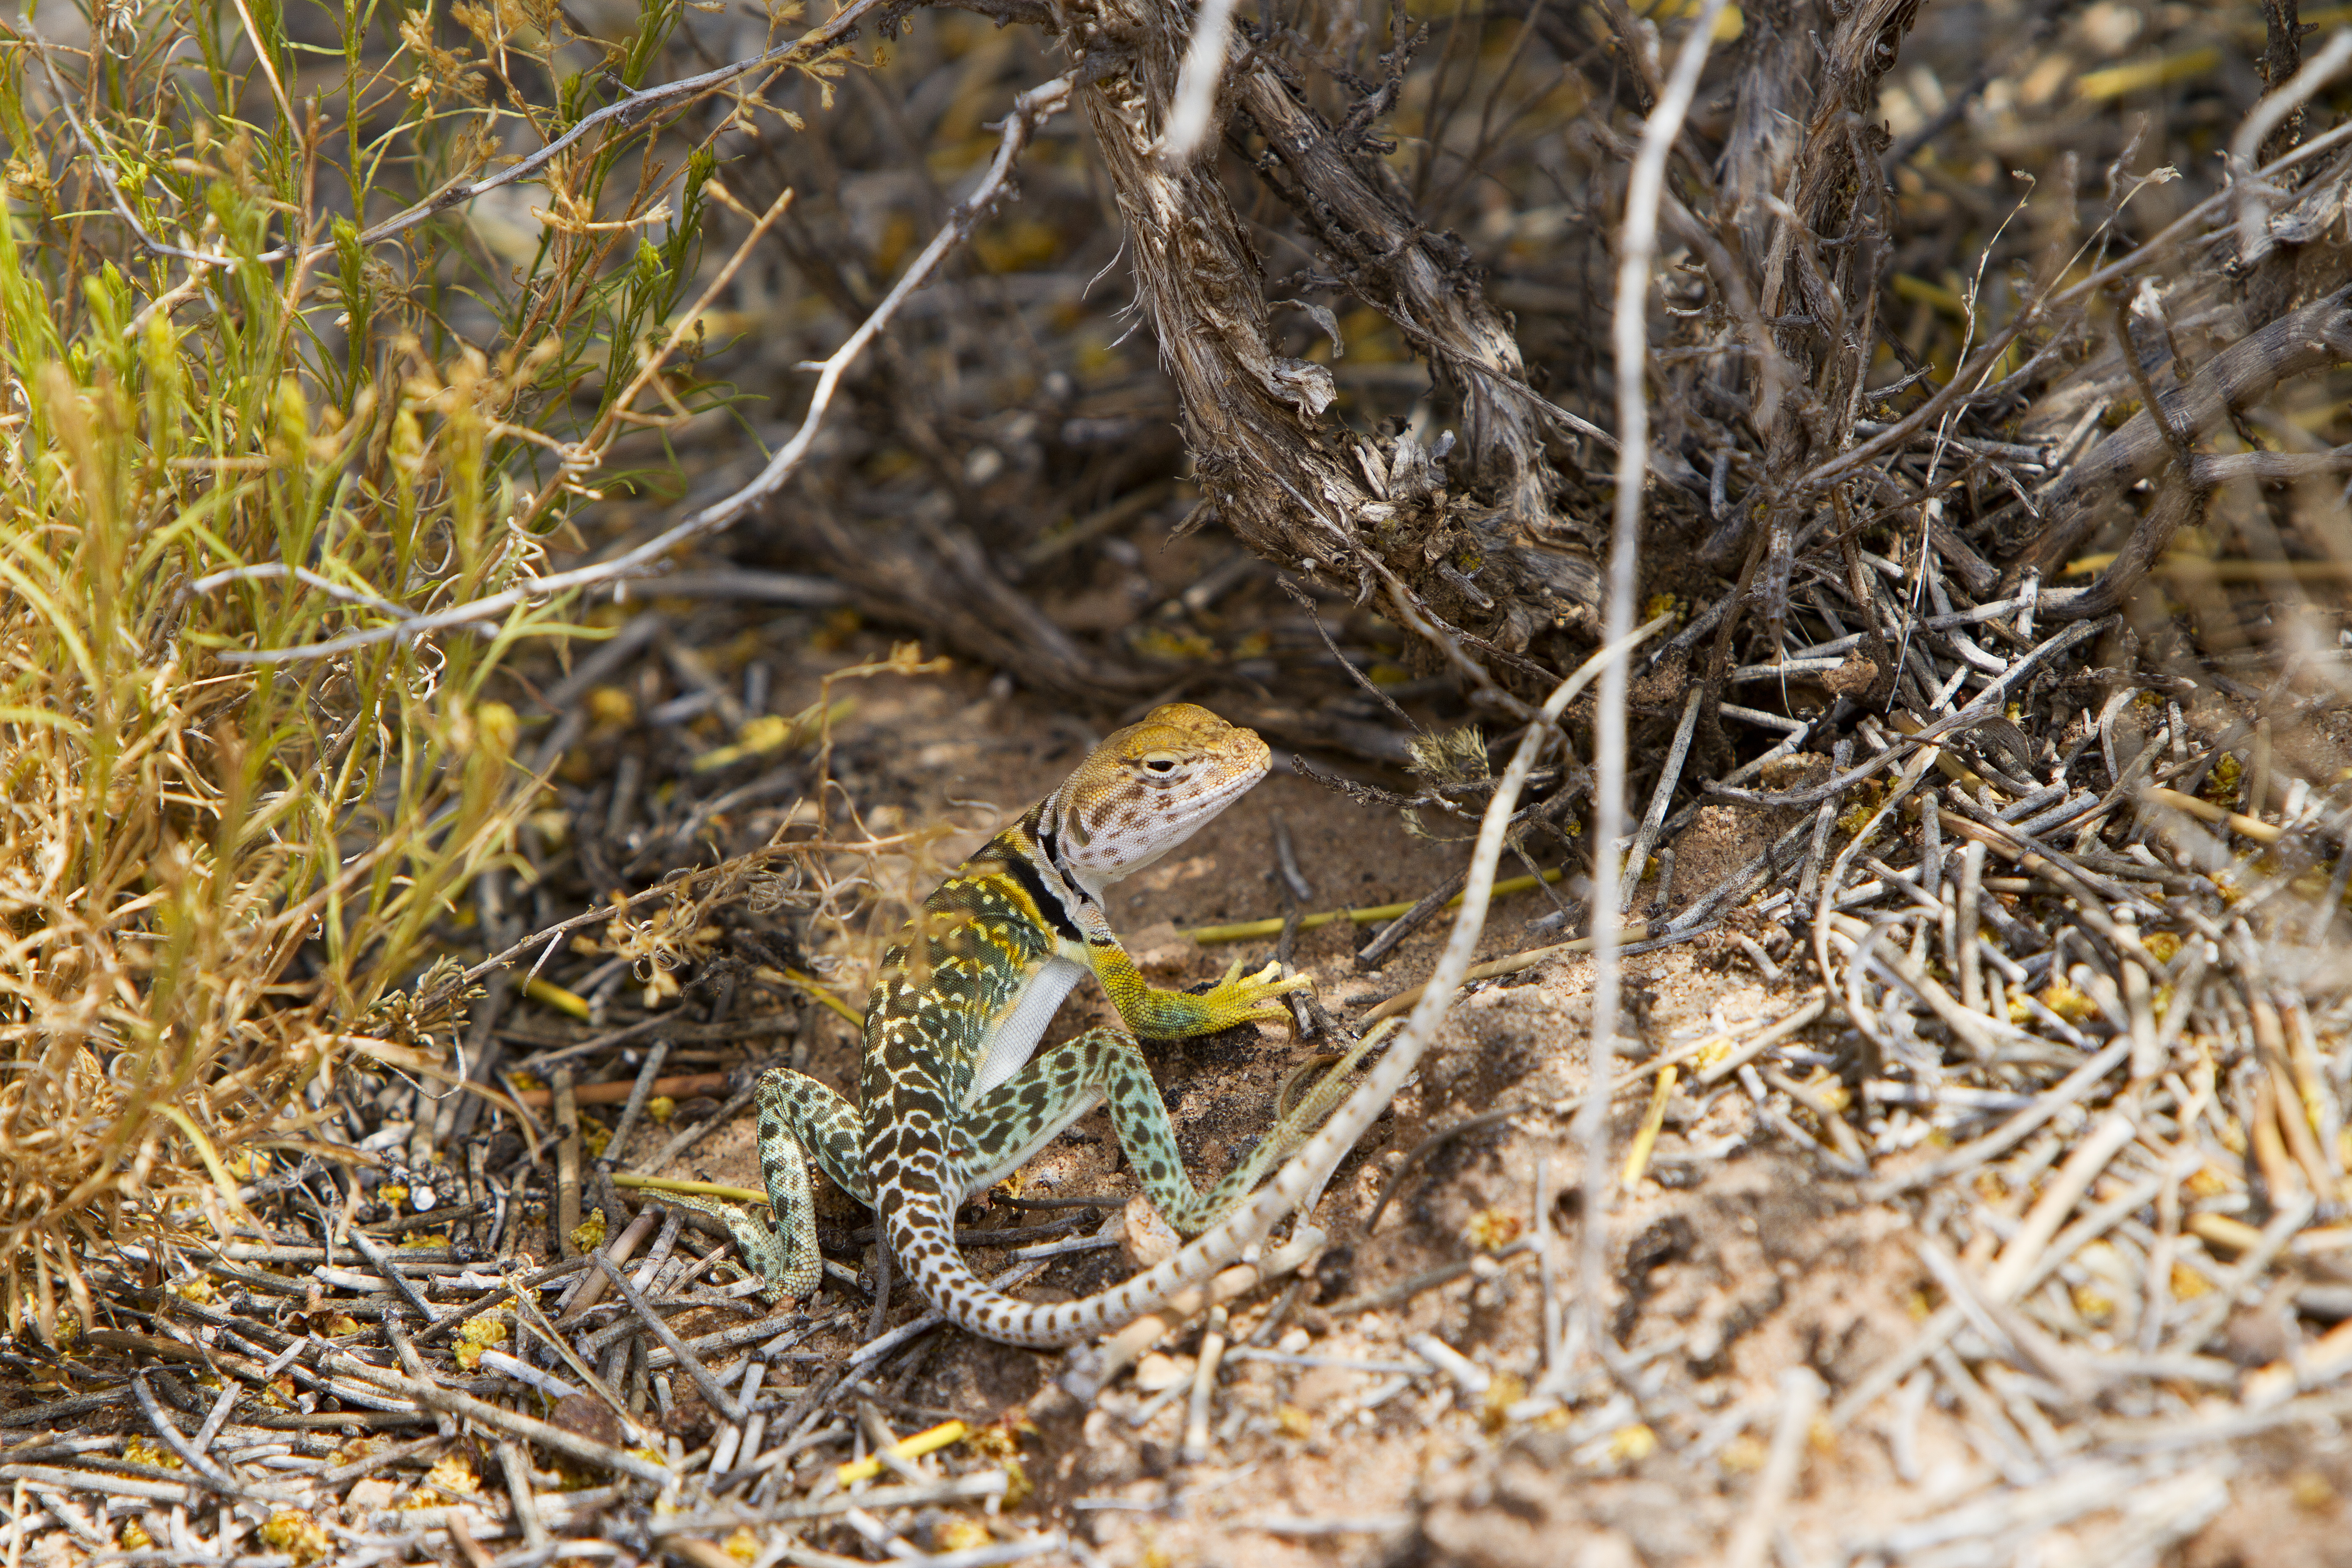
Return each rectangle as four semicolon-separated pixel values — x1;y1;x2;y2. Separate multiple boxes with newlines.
696;703;1341;1347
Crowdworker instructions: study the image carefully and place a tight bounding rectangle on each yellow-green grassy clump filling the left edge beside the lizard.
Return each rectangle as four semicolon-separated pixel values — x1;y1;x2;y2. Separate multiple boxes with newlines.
0;5;762;1340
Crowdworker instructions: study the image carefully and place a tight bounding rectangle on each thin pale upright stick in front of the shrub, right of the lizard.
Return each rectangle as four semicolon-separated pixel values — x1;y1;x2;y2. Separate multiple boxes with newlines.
1555;0;1724;1373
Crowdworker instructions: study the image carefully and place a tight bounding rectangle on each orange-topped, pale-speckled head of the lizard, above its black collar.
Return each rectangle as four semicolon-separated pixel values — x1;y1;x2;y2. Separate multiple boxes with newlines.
1037;703;1270;889
